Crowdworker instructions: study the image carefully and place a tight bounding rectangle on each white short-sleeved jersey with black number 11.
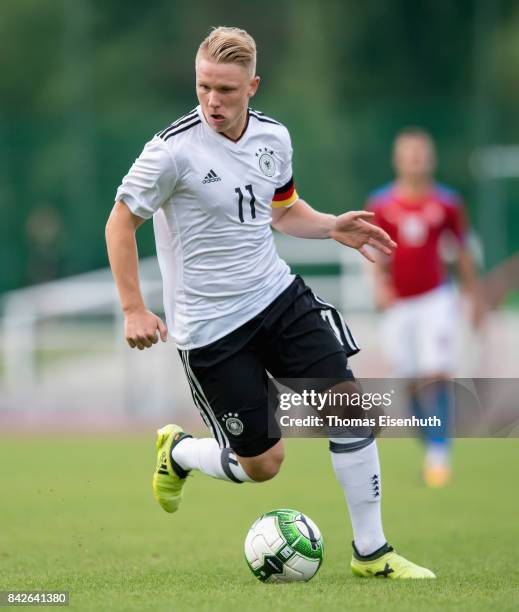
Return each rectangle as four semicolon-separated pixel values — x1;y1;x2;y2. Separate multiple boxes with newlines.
116;107;298;350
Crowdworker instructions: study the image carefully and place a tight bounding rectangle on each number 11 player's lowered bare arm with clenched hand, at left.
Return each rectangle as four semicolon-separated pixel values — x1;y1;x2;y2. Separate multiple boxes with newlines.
106;201;167;350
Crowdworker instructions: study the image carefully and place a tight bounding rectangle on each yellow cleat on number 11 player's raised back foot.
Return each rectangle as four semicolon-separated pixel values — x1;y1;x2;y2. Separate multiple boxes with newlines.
152;425;192;512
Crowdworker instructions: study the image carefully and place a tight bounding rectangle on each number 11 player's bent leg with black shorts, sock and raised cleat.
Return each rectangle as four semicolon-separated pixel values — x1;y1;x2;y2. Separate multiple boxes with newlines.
153;349;284;512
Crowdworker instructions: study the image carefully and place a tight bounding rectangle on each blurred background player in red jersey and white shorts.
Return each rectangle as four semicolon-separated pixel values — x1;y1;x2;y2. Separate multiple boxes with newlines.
367;128;482;487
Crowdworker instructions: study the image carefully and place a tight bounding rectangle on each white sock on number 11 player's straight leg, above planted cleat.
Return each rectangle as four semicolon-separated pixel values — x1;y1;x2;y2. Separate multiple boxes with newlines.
330;442;386;555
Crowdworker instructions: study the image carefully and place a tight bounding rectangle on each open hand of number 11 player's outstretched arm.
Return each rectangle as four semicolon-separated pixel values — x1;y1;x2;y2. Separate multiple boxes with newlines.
330;210;396;263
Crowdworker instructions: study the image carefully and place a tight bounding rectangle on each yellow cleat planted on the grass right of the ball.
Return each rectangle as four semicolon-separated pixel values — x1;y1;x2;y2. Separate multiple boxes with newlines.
351;544;436;580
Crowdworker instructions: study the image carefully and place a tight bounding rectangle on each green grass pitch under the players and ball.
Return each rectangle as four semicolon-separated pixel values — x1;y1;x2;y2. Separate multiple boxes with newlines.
0;435;519;612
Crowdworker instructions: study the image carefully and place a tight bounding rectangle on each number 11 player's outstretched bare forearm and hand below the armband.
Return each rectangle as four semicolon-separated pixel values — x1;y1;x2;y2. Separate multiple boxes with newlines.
272;199;396;262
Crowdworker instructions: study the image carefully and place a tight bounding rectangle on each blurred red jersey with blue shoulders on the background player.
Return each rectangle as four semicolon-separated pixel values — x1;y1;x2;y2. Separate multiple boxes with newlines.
367;183;465;297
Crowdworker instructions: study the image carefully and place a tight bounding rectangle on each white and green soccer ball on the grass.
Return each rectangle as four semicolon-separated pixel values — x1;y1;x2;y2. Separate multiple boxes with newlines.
245;509;323;582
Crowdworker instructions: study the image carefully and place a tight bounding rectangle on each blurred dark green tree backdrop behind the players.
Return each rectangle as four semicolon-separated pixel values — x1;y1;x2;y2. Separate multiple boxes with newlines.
0;0;519;291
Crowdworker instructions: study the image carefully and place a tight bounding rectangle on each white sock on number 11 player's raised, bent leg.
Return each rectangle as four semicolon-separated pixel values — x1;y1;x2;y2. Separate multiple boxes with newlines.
171;438;255;482
